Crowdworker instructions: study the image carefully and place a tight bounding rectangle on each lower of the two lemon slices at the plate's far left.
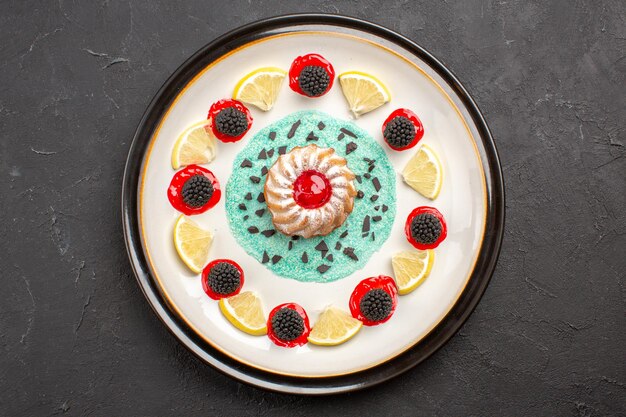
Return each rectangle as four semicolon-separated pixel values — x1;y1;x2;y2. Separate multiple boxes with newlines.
174;215;213;274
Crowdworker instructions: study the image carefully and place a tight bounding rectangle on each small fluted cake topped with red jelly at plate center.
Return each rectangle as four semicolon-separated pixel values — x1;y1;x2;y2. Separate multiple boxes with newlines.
264;145;357;238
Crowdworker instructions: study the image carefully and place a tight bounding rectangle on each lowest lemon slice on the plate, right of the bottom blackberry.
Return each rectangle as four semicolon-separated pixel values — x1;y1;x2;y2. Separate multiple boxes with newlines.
308;307;363;346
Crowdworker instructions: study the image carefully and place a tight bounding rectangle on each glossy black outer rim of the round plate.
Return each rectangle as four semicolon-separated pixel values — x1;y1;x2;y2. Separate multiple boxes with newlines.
121;13;505;395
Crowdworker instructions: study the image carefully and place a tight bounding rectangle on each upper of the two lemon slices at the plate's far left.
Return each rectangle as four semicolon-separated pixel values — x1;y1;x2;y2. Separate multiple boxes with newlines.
172;120;216;169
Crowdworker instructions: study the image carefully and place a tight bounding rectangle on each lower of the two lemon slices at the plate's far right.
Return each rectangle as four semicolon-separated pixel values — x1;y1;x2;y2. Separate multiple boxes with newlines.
391;249;435;295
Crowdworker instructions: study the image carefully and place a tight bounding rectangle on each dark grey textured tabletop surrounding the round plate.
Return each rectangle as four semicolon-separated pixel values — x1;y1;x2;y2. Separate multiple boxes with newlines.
0;0;626;416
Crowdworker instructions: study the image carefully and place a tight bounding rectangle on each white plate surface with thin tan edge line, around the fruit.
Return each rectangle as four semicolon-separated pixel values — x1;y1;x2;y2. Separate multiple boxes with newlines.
122;15;501;394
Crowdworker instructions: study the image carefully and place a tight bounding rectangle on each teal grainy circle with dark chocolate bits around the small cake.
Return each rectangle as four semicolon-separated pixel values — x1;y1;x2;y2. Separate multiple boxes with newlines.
226;111;396;282
